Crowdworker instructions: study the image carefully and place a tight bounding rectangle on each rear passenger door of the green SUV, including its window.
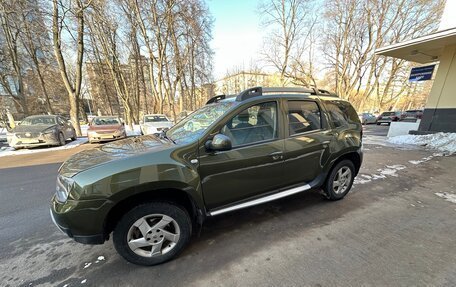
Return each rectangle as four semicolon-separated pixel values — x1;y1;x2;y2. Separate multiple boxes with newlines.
284;99;332;185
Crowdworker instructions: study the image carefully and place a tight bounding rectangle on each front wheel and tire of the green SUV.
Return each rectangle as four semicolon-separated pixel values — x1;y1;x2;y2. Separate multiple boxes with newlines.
113;202;192;266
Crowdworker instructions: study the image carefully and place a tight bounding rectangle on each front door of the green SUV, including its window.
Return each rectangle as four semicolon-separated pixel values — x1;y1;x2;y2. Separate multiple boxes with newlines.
199;101;284;209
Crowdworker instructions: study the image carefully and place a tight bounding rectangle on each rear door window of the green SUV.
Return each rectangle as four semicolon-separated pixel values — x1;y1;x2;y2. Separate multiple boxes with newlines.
288;101;321;135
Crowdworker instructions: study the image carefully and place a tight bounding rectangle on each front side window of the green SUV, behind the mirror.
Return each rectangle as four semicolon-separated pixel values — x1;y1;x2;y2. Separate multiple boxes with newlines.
221;102;277;146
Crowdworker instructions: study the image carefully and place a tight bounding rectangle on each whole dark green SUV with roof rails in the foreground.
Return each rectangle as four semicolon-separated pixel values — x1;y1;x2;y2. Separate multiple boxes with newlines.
51;87;363;265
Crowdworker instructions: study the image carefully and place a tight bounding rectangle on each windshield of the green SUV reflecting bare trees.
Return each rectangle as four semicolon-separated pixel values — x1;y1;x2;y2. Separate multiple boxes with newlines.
166;102;237;144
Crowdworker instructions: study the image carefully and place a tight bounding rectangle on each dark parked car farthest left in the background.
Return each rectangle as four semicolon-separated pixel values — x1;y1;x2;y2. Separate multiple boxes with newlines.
7;115;77;149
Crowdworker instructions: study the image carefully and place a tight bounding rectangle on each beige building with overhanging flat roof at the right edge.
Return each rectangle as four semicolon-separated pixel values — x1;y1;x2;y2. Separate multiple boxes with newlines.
376;1;456;134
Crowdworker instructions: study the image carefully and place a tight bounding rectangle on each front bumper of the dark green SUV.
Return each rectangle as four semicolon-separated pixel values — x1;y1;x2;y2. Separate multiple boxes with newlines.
50;198;109;244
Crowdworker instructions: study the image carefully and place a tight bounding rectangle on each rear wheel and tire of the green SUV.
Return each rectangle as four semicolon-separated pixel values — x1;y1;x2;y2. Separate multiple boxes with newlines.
323;160;355;200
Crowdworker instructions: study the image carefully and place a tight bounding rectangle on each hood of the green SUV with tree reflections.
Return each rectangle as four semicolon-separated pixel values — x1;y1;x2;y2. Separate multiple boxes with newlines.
60;136;174;177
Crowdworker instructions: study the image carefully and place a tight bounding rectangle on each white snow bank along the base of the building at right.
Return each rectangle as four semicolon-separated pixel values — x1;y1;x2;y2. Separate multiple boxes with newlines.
388;133;456;155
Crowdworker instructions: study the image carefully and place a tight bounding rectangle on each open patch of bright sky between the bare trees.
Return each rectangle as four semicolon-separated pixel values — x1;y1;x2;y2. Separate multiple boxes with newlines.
206;0;263;80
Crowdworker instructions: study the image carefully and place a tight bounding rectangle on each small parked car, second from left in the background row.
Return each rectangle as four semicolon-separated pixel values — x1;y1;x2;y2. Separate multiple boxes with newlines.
87;116;127;143
